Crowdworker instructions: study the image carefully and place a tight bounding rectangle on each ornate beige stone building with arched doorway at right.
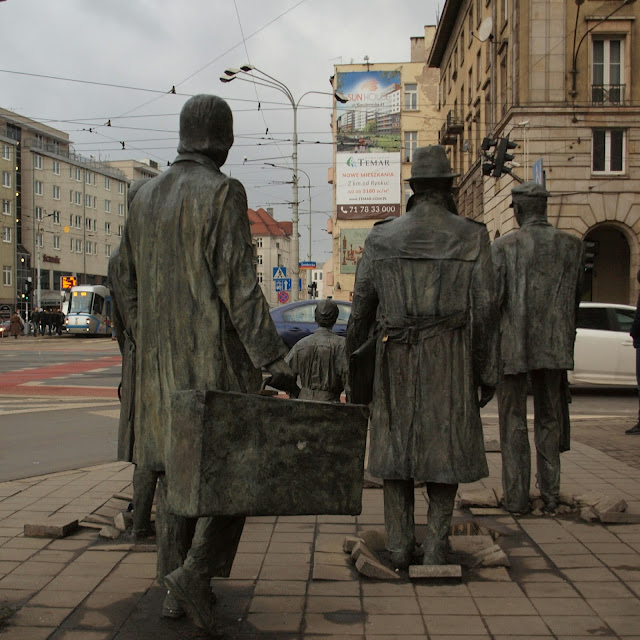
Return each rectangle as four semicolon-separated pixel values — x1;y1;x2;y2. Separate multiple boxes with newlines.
429;0;640;304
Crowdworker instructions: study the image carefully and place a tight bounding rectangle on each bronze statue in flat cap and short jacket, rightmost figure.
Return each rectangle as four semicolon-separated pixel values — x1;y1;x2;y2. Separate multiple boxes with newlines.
492;182;583;513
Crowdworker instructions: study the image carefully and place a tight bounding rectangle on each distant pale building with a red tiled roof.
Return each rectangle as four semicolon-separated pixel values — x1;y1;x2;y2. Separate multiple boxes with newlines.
248;207;292;307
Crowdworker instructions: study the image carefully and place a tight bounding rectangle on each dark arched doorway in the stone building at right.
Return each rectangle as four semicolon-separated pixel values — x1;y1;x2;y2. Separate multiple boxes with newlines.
582;224;630;304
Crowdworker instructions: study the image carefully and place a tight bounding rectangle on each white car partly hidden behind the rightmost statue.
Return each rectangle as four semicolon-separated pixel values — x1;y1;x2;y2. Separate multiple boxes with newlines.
568;302;637;387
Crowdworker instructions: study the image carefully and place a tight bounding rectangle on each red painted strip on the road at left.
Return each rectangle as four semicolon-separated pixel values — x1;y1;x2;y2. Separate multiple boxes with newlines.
0;356;122;398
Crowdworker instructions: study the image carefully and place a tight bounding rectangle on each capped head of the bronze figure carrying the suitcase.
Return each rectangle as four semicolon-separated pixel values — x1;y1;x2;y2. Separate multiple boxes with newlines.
178;94;233;167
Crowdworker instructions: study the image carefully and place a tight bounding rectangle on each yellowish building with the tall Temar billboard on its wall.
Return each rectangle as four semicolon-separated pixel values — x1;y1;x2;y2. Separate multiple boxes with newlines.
323;26;441;300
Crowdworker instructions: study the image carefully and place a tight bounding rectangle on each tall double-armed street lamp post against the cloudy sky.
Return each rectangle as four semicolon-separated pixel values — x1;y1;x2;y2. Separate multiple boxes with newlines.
220;64;347;302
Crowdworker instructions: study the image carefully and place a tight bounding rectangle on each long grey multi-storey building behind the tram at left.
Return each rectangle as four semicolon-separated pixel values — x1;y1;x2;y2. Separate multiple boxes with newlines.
0;109;128;314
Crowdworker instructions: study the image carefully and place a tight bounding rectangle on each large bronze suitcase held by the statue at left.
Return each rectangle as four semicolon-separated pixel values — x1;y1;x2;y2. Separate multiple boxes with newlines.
166;391;368;517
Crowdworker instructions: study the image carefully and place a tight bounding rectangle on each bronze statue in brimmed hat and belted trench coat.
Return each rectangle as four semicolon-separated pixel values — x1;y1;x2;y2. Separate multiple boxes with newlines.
347;146;498;568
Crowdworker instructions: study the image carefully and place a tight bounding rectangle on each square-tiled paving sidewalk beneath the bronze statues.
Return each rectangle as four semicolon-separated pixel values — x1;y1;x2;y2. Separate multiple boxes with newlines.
0;424;640;640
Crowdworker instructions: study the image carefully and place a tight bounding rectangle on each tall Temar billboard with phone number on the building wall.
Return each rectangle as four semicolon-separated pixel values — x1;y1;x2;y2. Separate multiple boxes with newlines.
335;71;402;220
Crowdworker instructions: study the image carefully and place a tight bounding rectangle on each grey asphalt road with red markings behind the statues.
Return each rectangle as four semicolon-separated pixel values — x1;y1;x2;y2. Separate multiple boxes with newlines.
0;336;640;481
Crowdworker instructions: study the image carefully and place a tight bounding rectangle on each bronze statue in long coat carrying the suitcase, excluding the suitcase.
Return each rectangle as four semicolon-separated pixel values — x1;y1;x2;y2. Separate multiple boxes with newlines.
113;95;295;632
